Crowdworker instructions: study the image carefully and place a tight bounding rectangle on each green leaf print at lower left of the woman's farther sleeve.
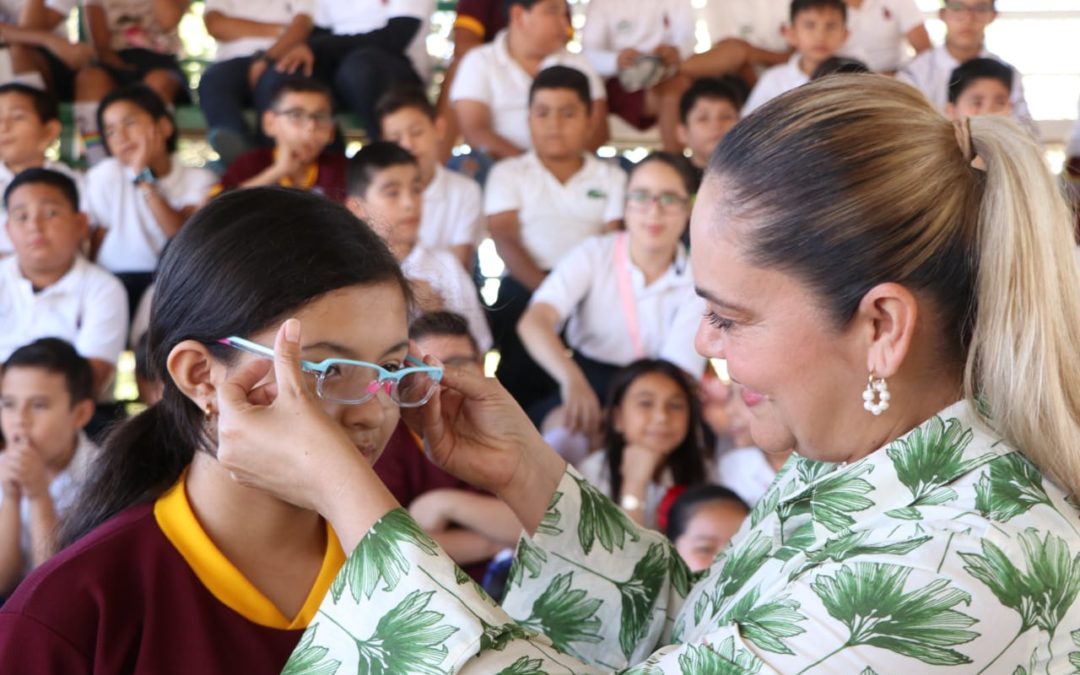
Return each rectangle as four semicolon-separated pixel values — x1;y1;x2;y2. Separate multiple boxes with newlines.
522;572;604;656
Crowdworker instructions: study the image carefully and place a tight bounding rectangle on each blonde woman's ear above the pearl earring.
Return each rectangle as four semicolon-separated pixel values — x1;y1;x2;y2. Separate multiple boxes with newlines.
855;283;919;378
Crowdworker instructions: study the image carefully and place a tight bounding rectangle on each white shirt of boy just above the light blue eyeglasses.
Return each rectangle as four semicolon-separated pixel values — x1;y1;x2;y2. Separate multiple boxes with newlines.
402;246;491;353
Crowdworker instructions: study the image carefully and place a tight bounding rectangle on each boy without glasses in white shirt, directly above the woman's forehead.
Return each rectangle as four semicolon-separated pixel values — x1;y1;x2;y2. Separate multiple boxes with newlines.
742;0;848;117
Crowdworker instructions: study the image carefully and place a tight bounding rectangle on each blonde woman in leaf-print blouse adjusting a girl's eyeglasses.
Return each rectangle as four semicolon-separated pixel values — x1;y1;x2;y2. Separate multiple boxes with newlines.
204;76;1080;674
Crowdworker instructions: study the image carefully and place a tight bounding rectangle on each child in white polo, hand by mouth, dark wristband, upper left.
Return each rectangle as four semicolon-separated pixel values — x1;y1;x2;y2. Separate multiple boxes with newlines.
86;84;215;313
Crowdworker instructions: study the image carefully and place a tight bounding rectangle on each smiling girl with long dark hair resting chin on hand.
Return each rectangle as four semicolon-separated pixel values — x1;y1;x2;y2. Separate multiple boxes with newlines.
578;359;706;528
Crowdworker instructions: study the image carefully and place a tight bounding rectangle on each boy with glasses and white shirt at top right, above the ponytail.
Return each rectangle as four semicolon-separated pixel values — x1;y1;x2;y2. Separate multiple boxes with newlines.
896;0;1031;125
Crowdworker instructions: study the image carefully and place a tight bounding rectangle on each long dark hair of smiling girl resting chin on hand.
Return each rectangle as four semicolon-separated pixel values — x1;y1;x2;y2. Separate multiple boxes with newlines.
604;359;705;499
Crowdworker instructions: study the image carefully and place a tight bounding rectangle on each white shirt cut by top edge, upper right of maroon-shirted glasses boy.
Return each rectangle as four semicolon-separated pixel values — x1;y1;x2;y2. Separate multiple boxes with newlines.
315;0;436;82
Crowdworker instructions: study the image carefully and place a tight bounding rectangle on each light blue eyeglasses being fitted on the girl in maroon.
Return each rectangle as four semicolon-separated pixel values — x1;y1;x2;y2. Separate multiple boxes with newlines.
218;337;443;408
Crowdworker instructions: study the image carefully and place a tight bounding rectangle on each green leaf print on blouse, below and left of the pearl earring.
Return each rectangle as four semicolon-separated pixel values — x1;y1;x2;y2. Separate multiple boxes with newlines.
778;462;874;533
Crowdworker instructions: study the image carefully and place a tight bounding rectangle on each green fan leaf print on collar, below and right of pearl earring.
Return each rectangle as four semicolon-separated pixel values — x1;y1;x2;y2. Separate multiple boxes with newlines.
886;417;995;519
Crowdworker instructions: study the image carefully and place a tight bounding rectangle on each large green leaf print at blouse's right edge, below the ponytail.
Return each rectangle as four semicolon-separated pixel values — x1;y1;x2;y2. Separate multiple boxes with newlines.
959;527;1080;670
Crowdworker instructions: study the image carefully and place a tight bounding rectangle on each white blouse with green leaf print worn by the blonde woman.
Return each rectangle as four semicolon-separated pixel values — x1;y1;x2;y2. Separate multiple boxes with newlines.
285;402;1080;675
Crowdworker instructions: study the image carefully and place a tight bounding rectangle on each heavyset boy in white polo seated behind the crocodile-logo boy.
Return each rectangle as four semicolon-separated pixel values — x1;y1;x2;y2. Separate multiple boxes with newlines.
450;0;608;160
